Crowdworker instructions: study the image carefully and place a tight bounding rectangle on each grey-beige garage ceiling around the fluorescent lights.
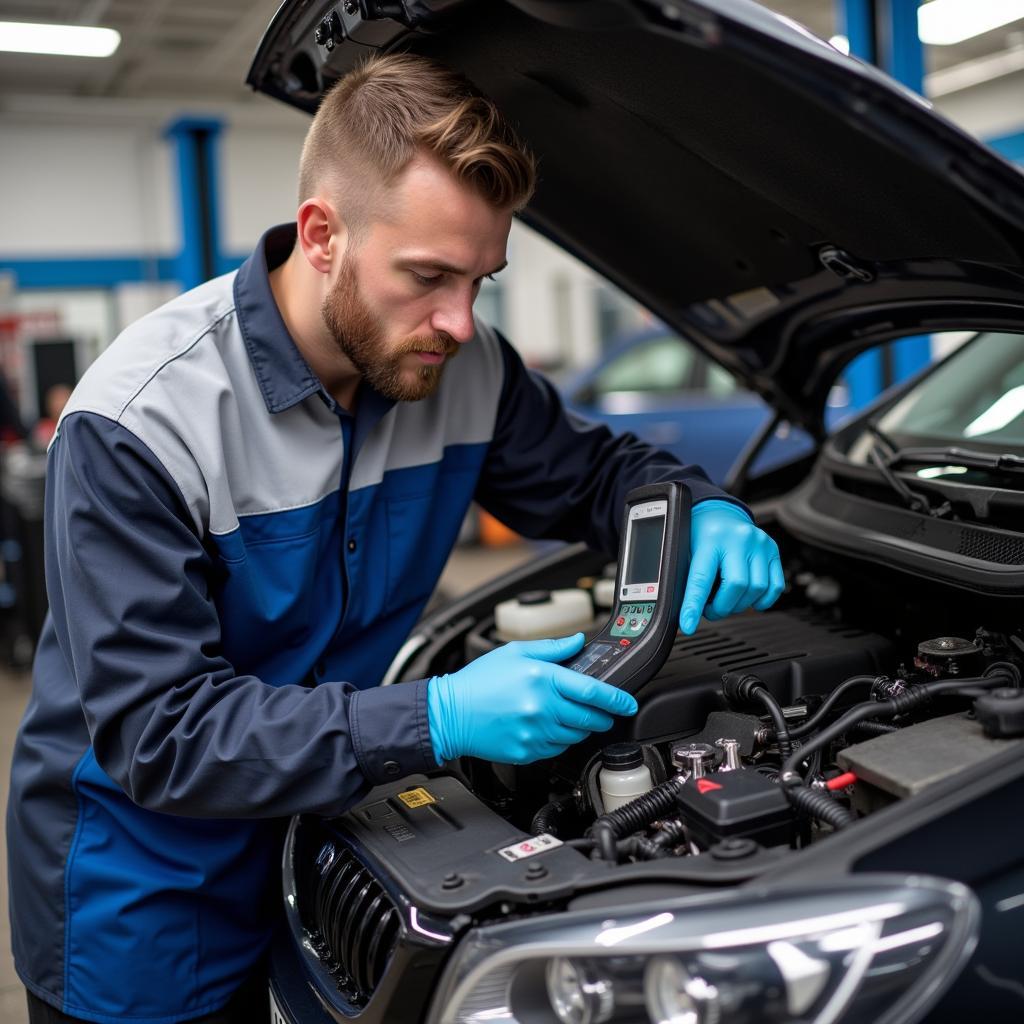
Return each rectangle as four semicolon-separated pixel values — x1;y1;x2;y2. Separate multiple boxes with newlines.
0;0;1024;102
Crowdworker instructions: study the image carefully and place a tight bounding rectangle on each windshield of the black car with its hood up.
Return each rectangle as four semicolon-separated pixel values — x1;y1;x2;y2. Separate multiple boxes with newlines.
878;333;1024;452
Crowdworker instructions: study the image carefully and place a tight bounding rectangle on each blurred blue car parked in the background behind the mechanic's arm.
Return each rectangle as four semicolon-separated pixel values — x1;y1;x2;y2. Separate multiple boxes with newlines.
561;325;849;483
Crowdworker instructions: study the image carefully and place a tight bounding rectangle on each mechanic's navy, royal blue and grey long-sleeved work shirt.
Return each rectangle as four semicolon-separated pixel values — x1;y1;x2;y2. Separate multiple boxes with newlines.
7;225;741;1024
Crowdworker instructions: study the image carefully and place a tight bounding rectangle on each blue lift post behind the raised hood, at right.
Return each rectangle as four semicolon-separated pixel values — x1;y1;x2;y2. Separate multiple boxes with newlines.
836;0;932;409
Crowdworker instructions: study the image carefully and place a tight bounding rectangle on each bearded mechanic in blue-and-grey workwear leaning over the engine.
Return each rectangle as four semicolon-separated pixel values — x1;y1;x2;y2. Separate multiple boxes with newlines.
7;56;783;1024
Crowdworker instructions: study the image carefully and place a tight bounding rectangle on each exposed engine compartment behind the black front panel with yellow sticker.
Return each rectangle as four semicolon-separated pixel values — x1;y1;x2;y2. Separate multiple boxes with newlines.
442;548;1024;865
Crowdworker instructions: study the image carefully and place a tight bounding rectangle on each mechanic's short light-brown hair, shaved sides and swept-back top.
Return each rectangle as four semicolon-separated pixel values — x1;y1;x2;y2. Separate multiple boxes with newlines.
299;54;537;230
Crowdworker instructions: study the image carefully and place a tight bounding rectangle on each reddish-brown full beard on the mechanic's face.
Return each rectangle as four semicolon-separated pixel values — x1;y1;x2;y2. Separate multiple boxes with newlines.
321;258;459;401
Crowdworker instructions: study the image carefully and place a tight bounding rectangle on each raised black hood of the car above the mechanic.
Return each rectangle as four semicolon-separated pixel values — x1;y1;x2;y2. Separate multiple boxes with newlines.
248;0;1024;432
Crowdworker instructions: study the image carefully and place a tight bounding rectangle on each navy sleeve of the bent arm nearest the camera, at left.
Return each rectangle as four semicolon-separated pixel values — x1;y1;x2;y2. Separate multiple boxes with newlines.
45;413;436;818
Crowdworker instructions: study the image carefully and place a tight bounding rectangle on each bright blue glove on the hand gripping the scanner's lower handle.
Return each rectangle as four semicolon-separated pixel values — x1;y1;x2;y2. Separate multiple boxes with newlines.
427;633;637;765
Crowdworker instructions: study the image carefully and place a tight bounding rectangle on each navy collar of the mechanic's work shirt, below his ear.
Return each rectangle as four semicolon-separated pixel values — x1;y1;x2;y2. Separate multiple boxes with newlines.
234;224;323;413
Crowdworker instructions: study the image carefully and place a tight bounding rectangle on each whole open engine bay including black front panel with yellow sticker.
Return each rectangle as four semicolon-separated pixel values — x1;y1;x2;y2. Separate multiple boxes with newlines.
305;544;1024;913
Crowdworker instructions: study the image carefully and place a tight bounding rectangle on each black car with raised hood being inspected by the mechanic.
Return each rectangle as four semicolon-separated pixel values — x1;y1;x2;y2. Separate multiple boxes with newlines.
250;0;1024;1024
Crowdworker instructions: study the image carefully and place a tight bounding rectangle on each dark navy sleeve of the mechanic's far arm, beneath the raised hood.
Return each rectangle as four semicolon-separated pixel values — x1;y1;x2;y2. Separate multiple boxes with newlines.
476;335;749;552
